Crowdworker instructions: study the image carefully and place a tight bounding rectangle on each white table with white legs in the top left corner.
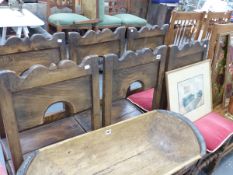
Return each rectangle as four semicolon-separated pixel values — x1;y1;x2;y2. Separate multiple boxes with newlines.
0;7;44;45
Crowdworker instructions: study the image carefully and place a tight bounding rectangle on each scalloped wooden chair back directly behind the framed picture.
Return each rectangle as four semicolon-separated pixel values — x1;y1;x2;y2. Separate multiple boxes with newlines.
161;40;208;109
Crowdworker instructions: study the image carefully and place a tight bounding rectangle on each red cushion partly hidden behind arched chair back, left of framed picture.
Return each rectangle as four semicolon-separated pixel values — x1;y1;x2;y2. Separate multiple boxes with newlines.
128;88;154;111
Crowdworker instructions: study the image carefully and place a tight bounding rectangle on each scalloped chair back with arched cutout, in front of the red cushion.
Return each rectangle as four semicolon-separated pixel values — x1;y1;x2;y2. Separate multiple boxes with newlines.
103;46;167;125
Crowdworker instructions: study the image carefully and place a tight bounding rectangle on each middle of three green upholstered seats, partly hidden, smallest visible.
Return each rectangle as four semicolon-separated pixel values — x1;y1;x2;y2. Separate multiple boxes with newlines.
96;15;121;27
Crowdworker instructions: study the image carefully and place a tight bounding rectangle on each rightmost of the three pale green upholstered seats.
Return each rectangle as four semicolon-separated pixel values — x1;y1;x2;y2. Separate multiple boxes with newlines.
114;14;147;27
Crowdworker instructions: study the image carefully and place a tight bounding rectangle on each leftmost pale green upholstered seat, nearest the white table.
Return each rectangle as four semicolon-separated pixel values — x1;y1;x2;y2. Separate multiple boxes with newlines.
48;13;91;26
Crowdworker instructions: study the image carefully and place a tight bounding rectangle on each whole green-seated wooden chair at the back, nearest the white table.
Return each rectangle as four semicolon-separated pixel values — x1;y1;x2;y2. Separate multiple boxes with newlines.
47;0;99;32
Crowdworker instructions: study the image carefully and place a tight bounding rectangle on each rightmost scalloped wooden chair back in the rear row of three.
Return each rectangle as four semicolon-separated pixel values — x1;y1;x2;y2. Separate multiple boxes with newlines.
127;24;168;51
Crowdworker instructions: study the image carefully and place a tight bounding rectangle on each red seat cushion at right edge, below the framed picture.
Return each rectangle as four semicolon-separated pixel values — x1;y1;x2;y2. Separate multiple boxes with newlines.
195;112;233;152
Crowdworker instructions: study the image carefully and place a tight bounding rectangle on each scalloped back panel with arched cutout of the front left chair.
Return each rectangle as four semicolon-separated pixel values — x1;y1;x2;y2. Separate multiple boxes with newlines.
0;60;98;131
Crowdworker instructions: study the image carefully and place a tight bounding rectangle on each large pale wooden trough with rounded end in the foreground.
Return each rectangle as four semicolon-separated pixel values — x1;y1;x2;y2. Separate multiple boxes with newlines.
17;111;205;175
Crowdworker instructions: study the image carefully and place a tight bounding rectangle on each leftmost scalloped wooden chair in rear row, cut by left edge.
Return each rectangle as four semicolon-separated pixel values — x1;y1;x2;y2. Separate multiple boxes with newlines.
0;32;66;136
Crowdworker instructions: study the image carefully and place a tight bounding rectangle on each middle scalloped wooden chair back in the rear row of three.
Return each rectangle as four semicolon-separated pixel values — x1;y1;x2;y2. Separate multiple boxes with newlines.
69;27;126;63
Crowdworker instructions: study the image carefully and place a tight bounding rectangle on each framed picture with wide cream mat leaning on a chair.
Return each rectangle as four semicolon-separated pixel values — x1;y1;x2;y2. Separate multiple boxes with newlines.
166;60;212;121
